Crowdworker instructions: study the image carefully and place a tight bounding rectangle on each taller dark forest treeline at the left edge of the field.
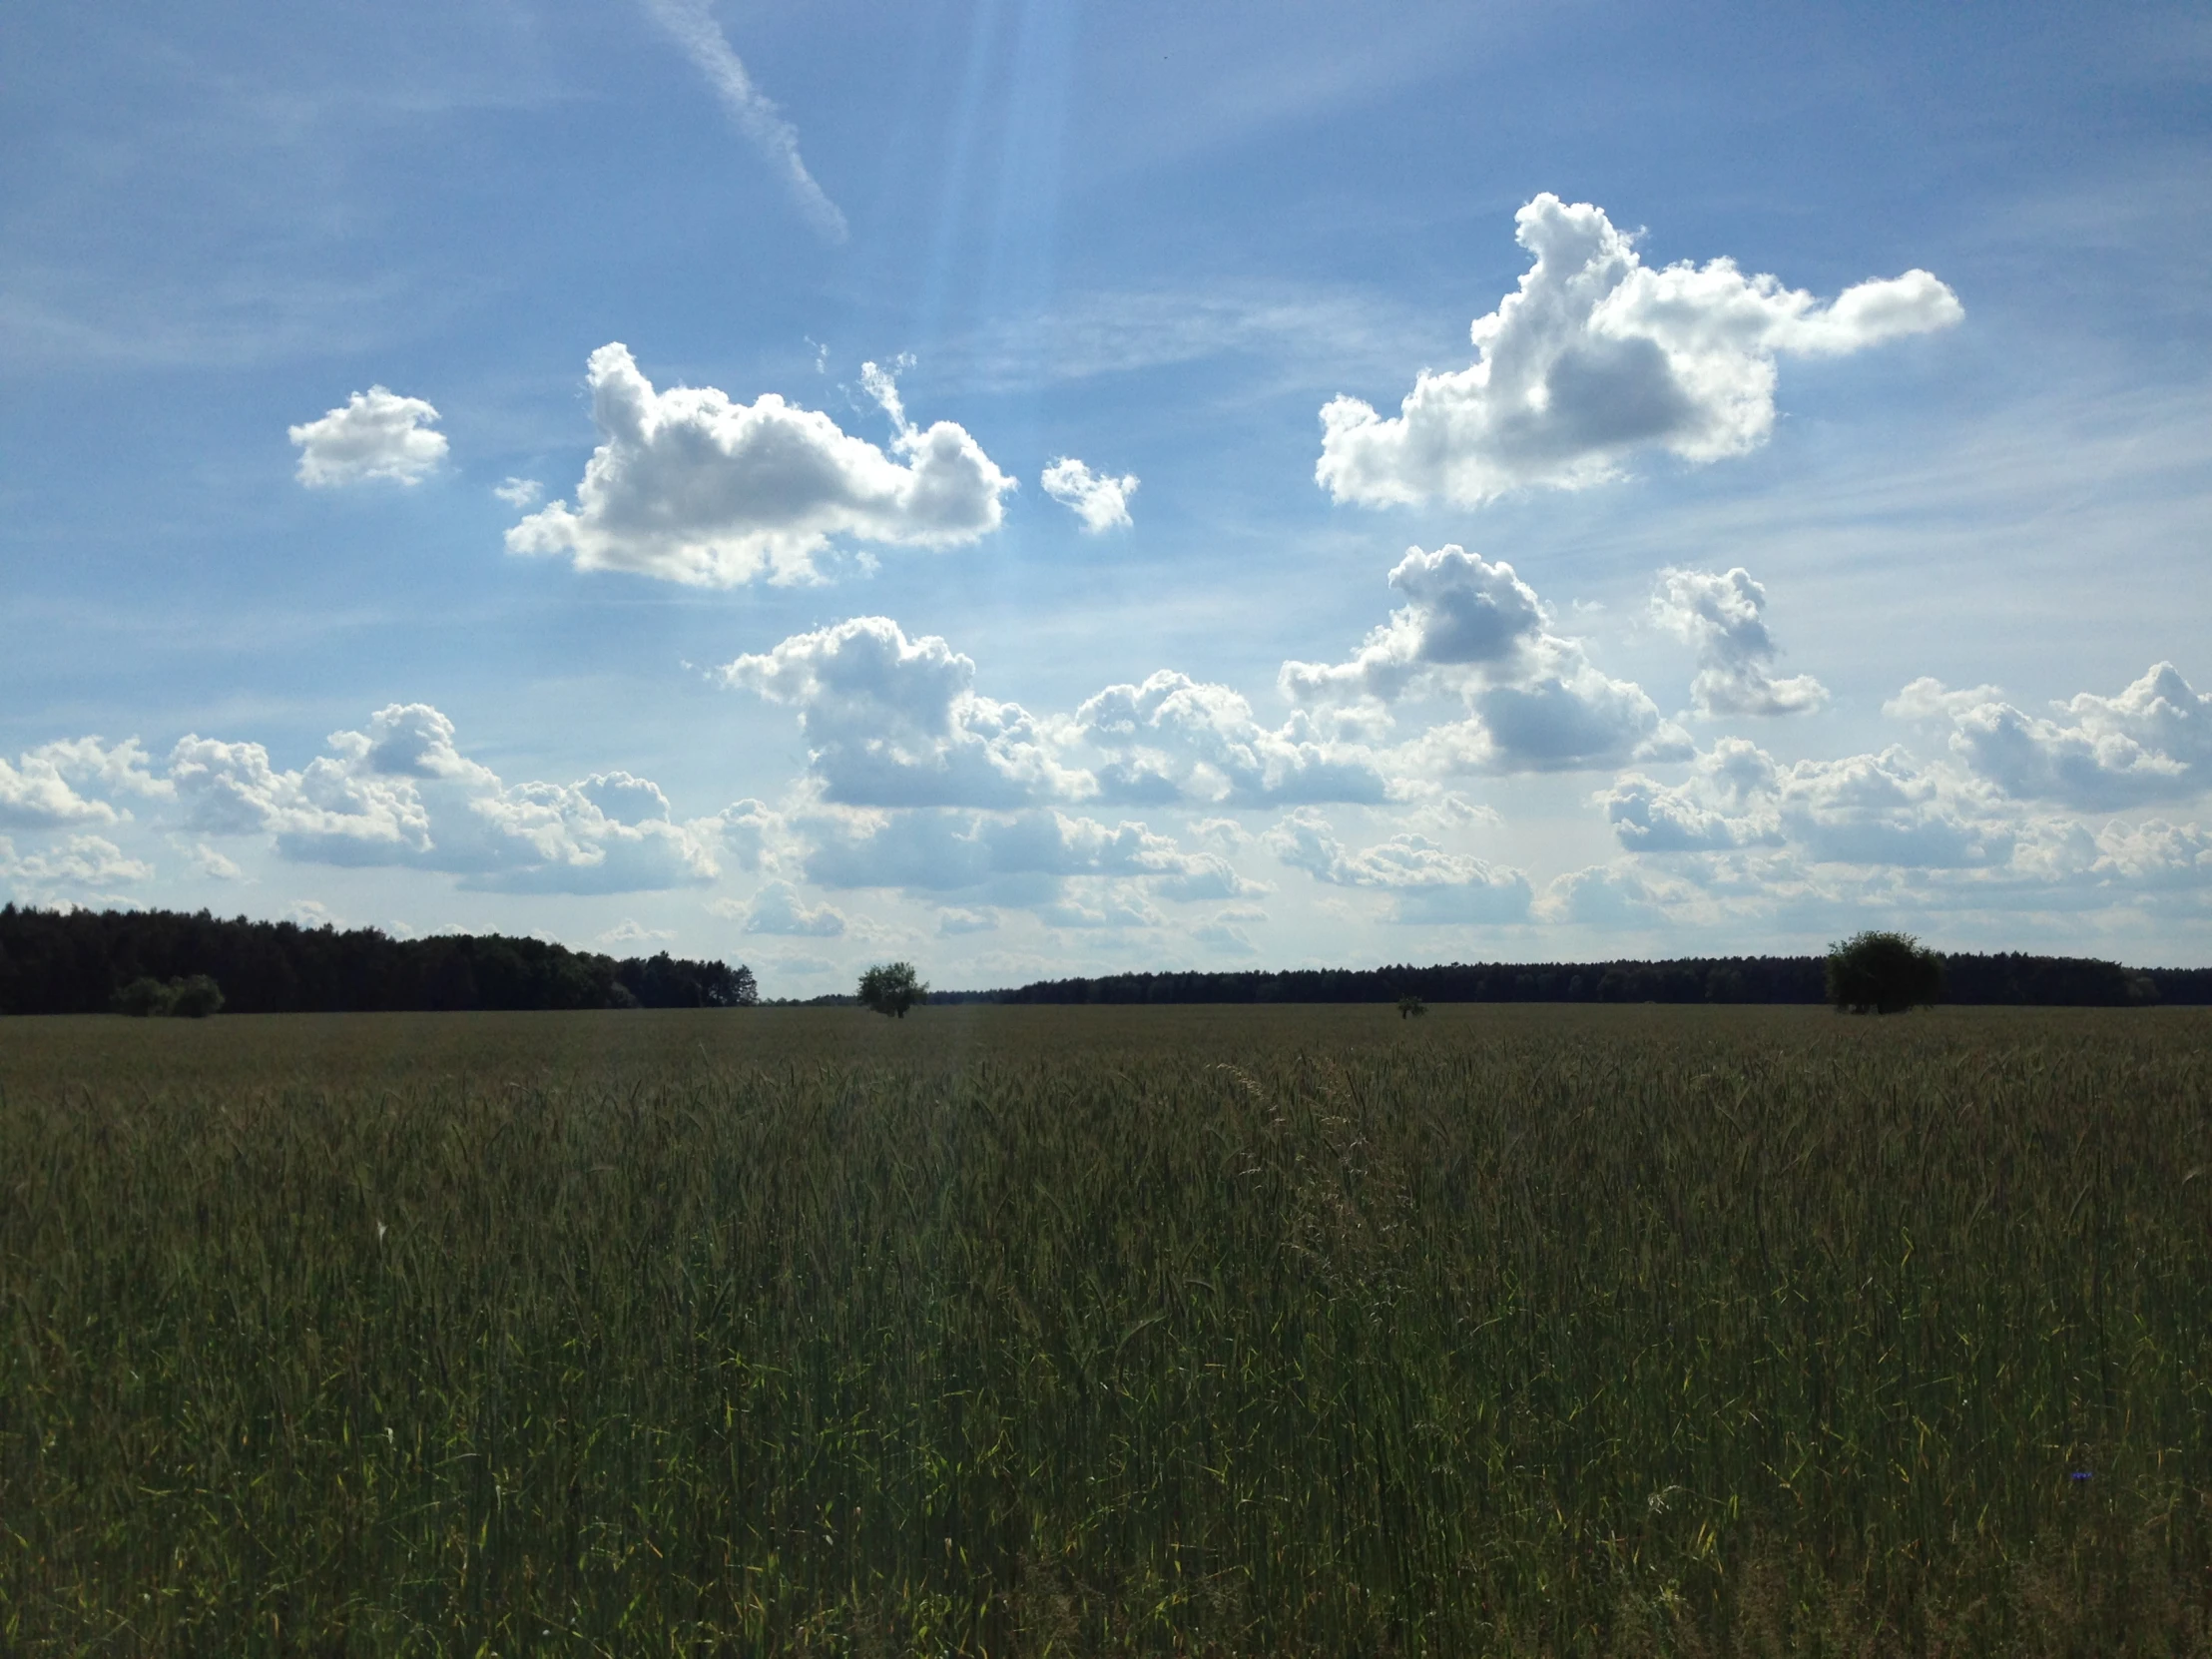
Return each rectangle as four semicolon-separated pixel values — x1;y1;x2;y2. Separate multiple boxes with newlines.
0;904;759;1013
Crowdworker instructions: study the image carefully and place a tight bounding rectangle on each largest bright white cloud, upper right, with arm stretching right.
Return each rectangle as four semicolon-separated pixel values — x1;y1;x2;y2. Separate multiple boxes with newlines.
1314;195;1964;506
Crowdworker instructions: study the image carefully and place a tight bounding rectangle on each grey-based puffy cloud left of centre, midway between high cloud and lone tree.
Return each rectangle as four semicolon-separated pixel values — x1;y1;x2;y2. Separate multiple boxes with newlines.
721;617;1093;808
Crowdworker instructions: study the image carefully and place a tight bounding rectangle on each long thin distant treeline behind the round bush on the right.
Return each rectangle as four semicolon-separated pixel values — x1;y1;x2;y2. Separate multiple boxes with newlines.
990;951;2212;1008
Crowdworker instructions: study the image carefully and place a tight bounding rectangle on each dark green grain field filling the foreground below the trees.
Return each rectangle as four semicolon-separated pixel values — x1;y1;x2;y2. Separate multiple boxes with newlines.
0;1006;2212;1659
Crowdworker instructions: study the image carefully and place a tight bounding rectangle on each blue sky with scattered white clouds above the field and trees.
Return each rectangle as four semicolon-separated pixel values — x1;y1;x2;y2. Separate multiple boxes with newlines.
0;0;2212;995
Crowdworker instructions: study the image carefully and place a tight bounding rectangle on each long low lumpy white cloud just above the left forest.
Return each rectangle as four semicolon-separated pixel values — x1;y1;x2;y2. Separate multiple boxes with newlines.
168;704;734;893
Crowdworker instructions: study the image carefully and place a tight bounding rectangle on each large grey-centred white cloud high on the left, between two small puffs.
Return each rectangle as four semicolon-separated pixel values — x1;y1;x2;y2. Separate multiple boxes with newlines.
506;342;1013;588
